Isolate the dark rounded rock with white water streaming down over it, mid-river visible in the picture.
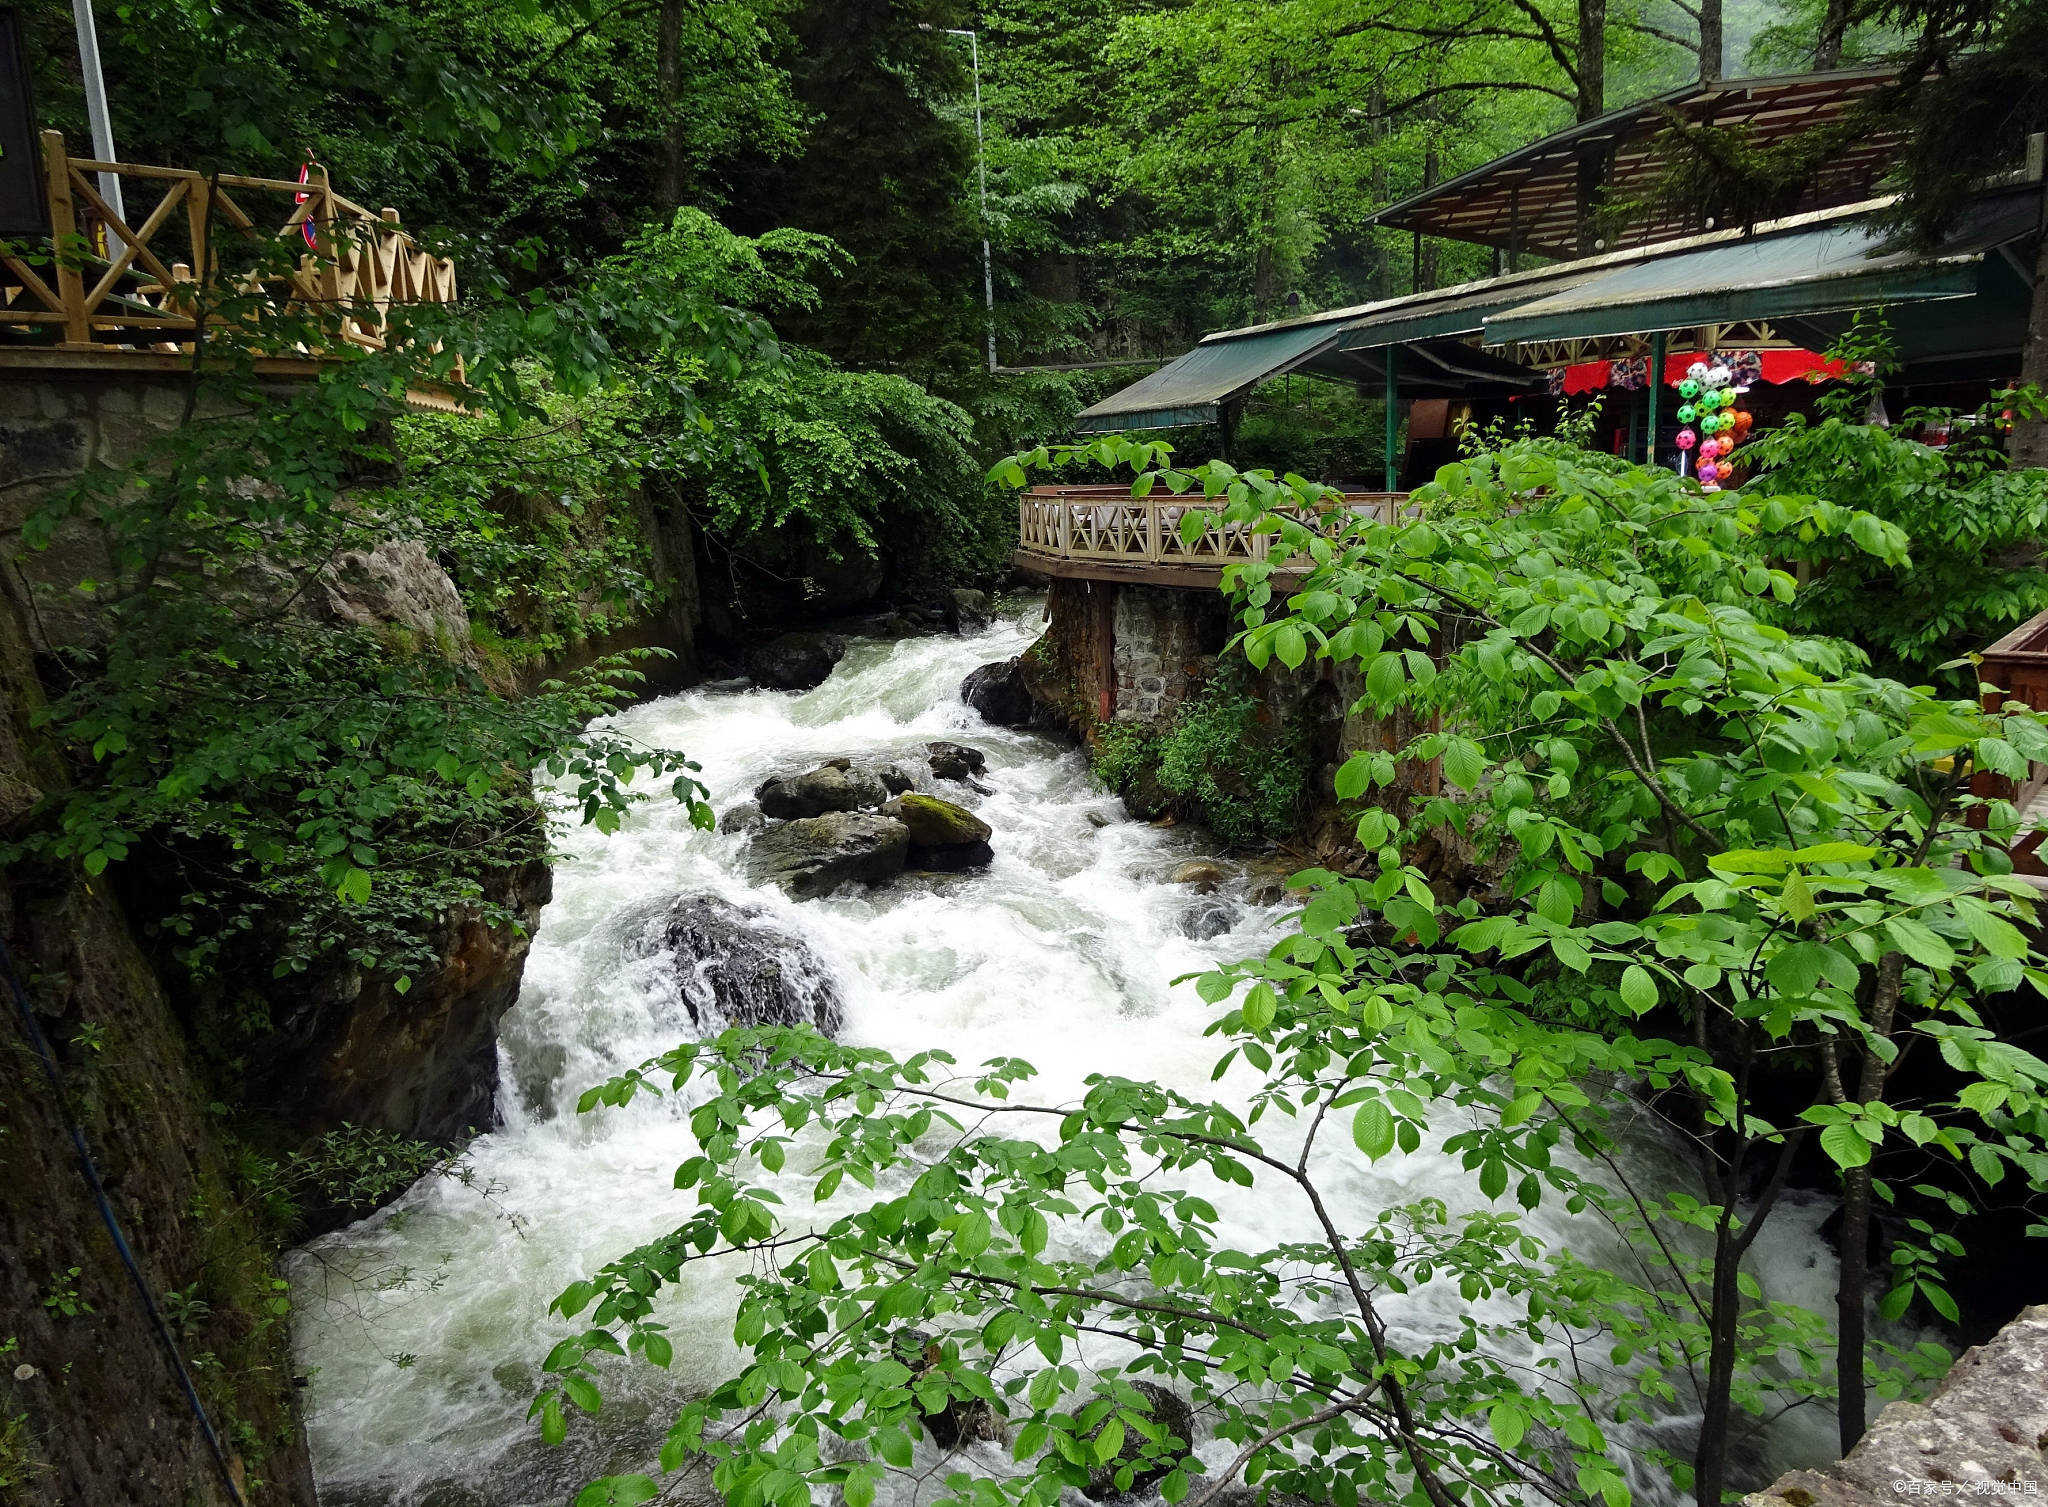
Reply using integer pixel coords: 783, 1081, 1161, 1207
635, 895, 842, 1036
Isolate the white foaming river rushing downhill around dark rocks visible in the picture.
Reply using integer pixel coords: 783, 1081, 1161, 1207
291, 602, 1835, 1507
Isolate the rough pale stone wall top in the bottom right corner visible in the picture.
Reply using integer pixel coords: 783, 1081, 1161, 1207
1743, 1306, 2048, 1507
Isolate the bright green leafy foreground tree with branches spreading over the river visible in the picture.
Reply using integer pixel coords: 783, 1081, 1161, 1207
503, 438, 2048, 1507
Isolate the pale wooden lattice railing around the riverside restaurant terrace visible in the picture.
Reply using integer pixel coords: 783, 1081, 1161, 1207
1018, 487, 1407, 569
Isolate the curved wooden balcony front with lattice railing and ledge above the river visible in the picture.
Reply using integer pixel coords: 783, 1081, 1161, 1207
1012, 485, 1407, 590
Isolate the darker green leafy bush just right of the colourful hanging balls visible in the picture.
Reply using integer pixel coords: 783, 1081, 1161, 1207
1743, 324, 2048, 692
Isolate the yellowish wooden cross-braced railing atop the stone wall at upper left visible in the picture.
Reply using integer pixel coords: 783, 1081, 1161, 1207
0, 131, 455, 356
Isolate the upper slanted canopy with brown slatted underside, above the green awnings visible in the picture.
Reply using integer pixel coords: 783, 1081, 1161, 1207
1372, 70, 1901, 258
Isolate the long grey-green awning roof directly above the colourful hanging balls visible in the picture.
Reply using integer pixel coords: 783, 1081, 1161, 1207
1485, 219, 2007, 346
